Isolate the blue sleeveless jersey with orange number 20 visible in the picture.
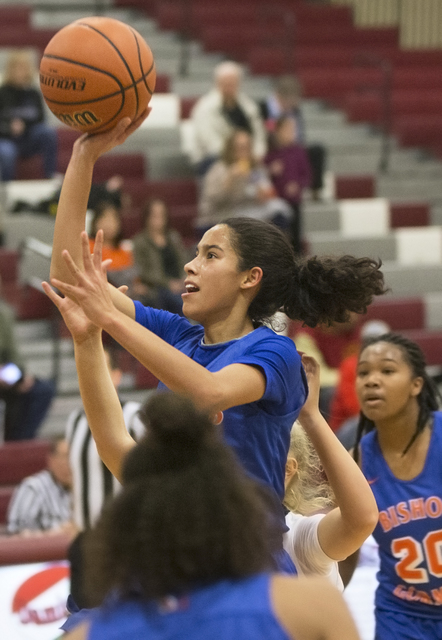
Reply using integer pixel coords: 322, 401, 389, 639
361, 412, 442, 619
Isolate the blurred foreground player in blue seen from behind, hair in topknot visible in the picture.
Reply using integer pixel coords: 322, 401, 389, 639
58, 390, 358, 640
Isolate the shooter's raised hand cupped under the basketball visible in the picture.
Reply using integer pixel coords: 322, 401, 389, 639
74, 107, 152, 162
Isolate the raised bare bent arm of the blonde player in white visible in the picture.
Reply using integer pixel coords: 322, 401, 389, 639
299, 355, 378, 560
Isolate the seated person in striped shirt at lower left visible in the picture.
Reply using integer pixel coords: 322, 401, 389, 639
7, 438, 74, 535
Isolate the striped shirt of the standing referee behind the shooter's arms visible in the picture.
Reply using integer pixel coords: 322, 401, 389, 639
66, 402, 145, 530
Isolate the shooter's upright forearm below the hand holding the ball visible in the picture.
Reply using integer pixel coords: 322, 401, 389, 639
51, 146, 94, 282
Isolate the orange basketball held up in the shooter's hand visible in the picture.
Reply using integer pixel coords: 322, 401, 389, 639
40, 17, 156, 132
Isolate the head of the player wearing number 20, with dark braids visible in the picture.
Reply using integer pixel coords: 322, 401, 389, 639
355, 333, 439, 458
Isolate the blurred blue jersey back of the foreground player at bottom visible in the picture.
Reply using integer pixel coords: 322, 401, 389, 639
88, 574, 289, 640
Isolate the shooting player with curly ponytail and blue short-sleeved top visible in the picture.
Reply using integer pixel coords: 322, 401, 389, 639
44, 111, 384, 560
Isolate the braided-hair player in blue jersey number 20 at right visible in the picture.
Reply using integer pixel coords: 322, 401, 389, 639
354, 333, 442, 640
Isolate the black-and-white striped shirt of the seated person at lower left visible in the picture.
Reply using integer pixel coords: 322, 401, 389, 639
7, 469, 72, 533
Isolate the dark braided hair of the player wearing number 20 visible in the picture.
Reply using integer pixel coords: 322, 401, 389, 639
353, 333, 441, 461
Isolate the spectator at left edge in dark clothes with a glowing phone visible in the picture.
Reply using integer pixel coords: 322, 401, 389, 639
0, 300, 55, 440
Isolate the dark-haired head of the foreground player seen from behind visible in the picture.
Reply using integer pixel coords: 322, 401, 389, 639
86, 393, 273, 602
